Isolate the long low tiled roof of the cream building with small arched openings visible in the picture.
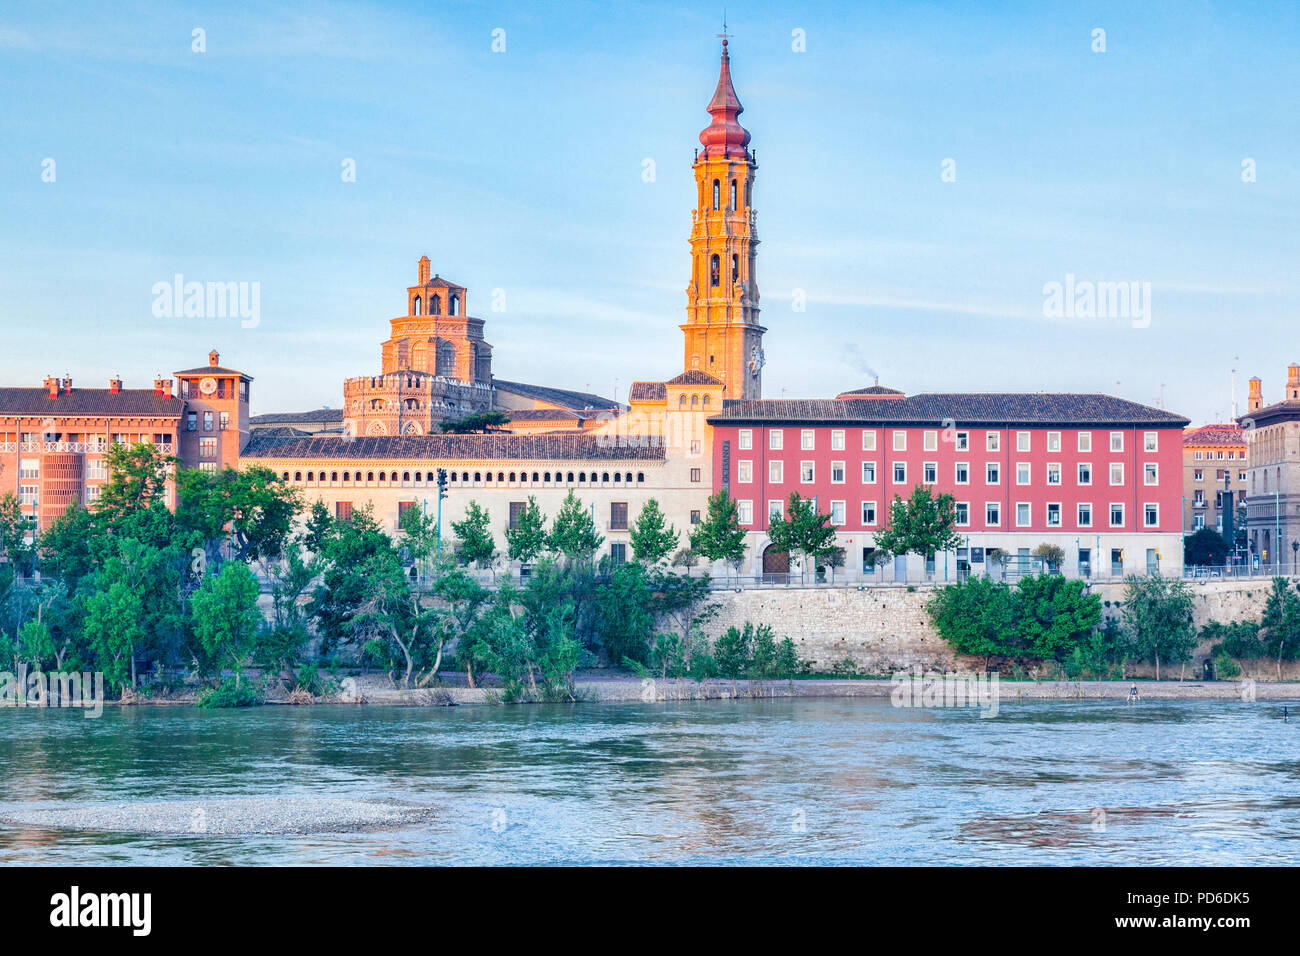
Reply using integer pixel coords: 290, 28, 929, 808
241, 432, 664, 462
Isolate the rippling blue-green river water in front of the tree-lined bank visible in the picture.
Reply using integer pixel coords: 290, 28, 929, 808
0, 698, 1300, 865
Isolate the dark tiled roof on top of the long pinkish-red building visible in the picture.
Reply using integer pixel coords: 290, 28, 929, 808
709, 392, 1188, 427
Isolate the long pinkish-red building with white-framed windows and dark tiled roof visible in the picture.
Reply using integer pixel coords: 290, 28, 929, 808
710, 385, 1187, 580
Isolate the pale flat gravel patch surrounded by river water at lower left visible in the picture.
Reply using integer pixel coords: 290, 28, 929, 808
0, 797, 432, 836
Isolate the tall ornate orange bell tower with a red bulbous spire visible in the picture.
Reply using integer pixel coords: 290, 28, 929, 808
681, 35, 767, 401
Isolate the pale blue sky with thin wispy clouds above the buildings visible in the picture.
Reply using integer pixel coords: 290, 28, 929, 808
0, 0, 1300, 424
